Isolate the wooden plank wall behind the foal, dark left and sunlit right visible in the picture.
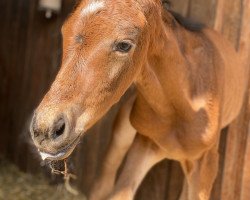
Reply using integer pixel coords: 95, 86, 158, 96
0, 0, 250, 200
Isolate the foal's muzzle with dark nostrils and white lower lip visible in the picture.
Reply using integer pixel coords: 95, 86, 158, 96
30, 113, 75, 159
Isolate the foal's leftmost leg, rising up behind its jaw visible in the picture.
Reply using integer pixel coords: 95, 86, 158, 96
89, 95, 136, 200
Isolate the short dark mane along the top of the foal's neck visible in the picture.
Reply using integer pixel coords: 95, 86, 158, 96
162, 0, 205, 31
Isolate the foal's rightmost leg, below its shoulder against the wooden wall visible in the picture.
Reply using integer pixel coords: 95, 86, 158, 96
180, 145, 219, 200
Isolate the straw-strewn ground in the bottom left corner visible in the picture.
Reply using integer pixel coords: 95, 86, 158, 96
0, 159, 86, 200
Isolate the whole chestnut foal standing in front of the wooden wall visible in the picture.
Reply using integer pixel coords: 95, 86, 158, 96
30, 0, 248, 200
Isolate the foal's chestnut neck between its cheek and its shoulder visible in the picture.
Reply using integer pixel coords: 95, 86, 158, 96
136, 14, 195, 118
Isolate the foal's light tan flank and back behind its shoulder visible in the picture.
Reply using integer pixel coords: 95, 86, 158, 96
204, 29, 248, 127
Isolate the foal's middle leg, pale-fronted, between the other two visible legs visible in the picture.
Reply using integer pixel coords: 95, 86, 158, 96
108, 134, 164, 200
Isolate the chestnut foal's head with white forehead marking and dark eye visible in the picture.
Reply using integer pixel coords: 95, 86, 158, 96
31, 0, 160, 159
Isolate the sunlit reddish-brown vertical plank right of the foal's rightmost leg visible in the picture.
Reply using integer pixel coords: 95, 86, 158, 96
221, 99, 249, 200
